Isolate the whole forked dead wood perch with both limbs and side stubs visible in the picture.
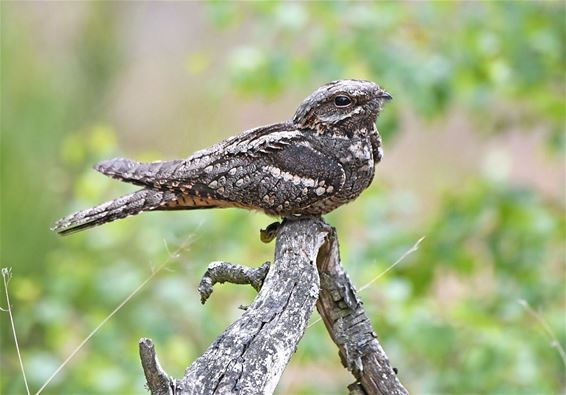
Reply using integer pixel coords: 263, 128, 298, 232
140, 218, 407, 395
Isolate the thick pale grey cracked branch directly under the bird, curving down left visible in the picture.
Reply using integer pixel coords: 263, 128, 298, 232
140, 218, 327, 394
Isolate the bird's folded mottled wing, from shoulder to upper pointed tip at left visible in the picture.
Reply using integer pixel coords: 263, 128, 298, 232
95, 124, 345, 212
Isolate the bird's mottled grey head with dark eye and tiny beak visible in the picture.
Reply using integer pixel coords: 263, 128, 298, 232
293, 80, 392, 132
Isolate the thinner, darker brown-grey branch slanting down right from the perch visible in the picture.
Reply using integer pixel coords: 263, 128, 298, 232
316, 229, 408, 395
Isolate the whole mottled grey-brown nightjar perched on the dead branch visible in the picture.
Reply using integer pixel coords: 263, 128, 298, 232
52, 79, 392, 235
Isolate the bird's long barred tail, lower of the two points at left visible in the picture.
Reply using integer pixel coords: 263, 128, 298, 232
51, 189, 176, 235
